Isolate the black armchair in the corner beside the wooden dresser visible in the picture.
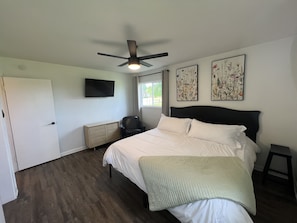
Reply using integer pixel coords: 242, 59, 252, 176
120, 116, 145, 138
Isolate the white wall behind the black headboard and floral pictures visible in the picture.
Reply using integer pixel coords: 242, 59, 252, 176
169, 36, 297, 173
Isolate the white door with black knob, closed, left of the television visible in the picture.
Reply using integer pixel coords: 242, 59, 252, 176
3, 77, 61, 170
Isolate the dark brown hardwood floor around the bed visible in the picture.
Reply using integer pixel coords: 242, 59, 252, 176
3, 148, 297, 223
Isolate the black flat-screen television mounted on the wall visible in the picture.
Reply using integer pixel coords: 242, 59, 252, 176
85, 78, 114, 97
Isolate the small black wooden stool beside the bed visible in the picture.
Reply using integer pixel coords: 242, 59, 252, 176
262, 144, 294, 193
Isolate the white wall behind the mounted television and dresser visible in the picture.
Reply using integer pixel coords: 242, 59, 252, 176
0, 57, 133, 155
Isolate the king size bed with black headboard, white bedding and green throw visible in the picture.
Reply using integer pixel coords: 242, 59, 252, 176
103, 106, 260, 223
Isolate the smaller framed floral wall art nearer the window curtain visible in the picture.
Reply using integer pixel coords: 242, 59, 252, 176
176, 65, 198, 101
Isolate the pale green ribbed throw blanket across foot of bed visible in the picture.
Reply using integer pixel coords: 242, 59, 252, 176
139, 156, 256, 215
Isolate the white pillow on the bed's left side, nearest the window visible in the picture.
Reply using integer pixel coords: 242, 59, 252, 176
157, 114, 191, 134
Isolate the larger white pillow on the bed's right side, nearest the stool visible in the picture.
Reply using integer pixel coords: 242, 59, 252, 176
188, 119, 246, 148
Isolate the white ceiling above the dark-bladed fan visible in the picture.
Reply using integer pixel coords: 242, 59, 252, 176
0, 0, 297, 73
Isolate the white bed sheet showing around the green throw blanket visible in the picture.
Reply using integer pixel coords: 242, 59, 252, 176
103, 129, 257, 223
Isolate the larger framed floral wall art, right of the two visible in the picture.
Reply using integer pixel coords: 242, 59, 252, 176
211, 54, 245, 101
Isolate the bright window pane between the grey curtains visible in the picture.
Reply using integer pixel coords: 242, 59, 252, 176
139, 81, 162, 107
